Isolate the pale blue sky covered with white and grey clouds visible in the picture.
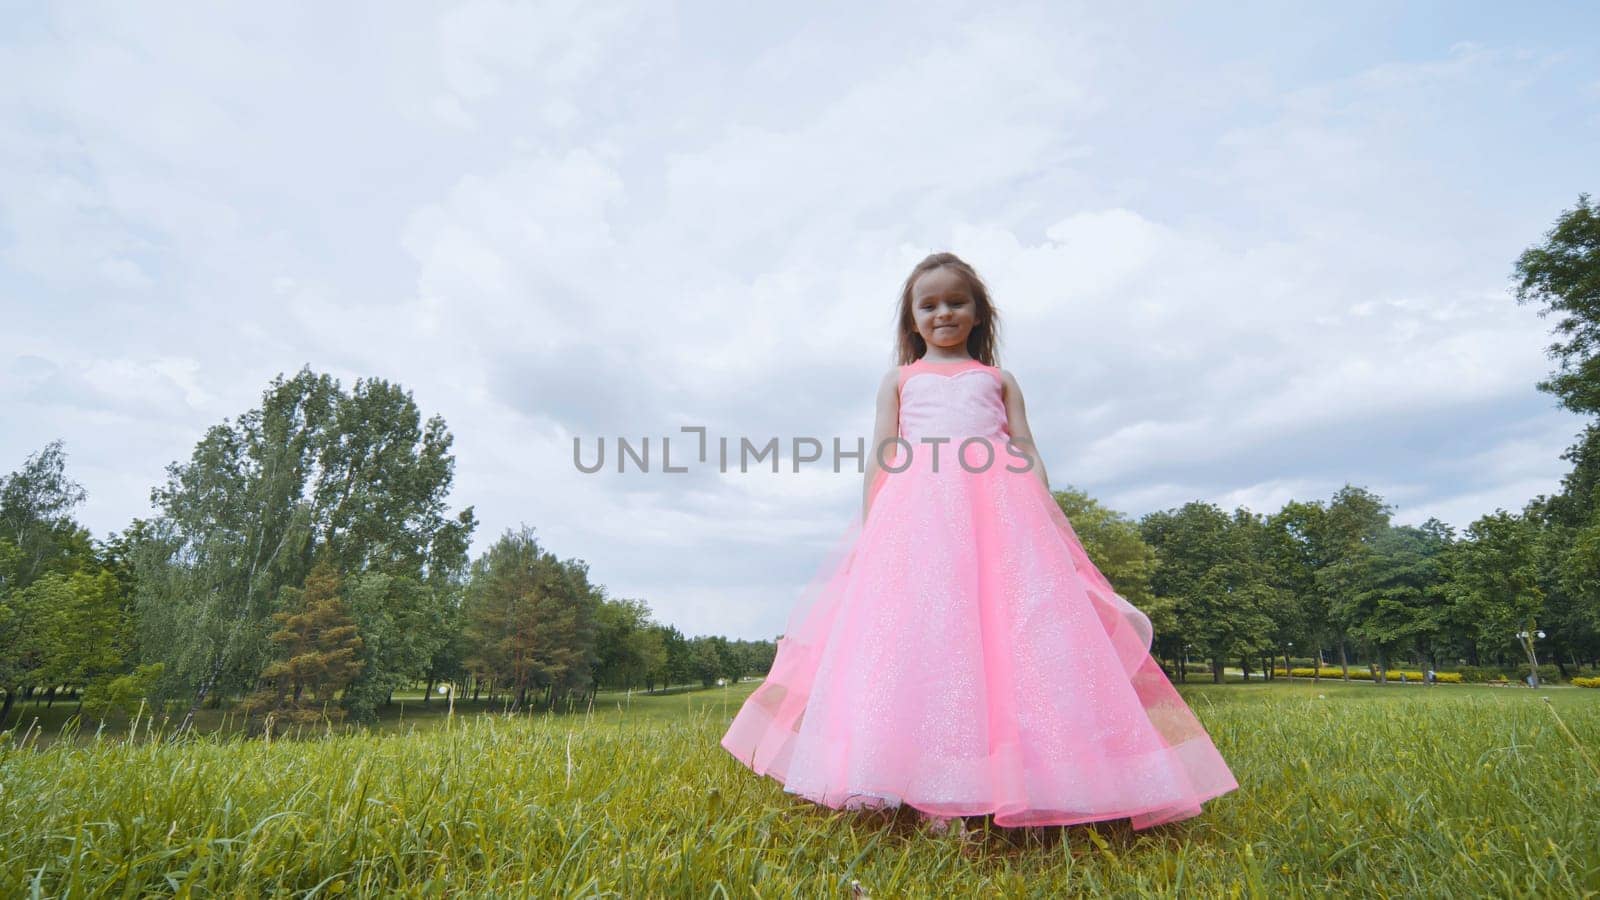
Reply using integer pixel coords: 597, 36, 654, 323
0, 2, 1600, 637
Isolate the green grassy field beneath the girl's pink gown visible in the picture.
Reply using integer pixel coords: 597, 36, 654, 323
0, 681, 1600, 897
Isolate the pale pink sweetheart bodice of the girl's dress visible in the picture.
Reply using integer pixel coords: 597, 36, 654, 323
899, 359, 1010, 444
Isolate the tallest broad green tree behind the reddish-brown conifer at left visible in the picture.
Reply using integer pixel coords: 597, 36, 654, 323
131, 368, 475, 729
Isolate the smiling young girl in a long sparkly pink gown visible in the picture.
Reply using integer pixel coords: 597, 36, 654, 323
722, 253, 1238, 828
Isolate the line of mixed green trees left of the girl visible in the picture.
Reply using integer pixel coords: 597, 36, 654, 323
0, 368, 774, 730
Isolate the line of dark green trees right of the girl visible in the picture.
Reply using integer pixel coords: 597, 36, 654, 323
1056, 194, 1600, 681
